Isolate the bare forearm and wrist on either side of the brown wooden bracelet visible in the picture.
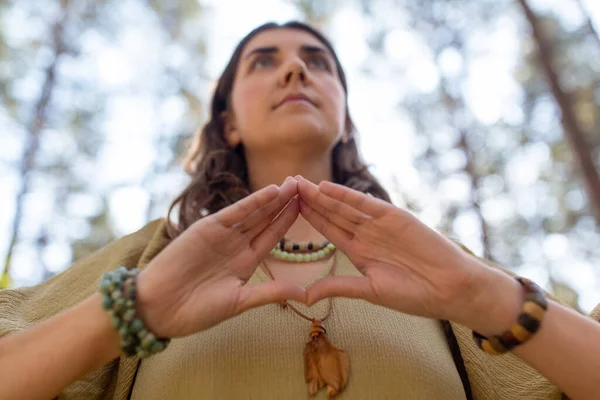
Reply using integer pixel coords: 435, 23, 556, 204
467, 270, 600, 400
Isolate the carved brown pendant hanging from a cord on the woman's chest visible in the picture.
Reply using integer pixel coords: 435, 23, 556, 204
304, 319, 350, 397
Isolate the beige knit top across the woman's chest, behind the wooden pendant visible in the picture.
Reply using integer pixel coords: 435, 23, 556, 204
132, 298, 465, 400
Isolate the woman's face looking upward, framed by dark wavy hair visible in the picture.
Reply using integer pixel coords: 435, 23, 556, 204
226, 29, 346, 153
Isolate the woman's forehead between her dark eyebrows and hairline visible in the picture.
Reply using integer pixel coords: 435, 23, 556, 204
242, 28, 331, 57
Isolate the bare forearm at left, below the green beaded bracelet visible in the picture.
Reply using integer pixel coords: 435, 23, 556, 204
0, 294, 120, 400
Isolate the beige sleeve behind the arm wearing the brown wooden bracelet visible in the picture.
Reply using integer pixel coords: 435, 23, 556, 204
452, 242, 600, 400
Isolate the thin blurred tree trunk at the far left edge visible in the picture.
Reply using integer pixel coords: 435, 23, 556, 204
0, 0, 68, 289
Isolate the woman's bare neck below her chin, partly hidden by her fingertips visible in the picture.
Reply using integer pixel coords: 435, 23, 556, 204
246, 148, 333, 243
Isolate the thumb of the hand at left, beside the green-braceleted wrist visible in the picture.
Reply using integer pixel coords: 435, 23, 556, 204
240, 281, 306, 312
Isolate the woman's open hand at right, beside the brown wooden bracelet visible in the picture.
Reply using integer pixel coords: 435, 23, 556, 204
296, 176, 521, 332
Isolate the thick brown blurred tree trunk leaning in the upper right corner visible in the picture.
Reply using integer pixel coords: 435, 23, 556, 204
518, 0, 600, 225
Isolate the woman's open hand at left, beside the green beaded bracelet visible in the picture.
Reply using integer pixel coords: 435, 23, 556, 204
136, 178, 307, 338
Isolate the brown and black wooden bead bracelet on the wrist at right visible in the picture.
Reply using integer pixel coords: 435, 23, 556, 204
473, 277, 548, 355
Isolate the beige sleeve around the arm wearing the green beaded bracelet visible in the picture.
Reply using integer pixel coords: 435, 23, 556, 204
0, 221, 164, 400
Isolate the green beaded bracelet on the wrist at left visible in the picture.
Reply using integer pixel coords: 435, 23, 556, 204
98, 267, 170, 358
